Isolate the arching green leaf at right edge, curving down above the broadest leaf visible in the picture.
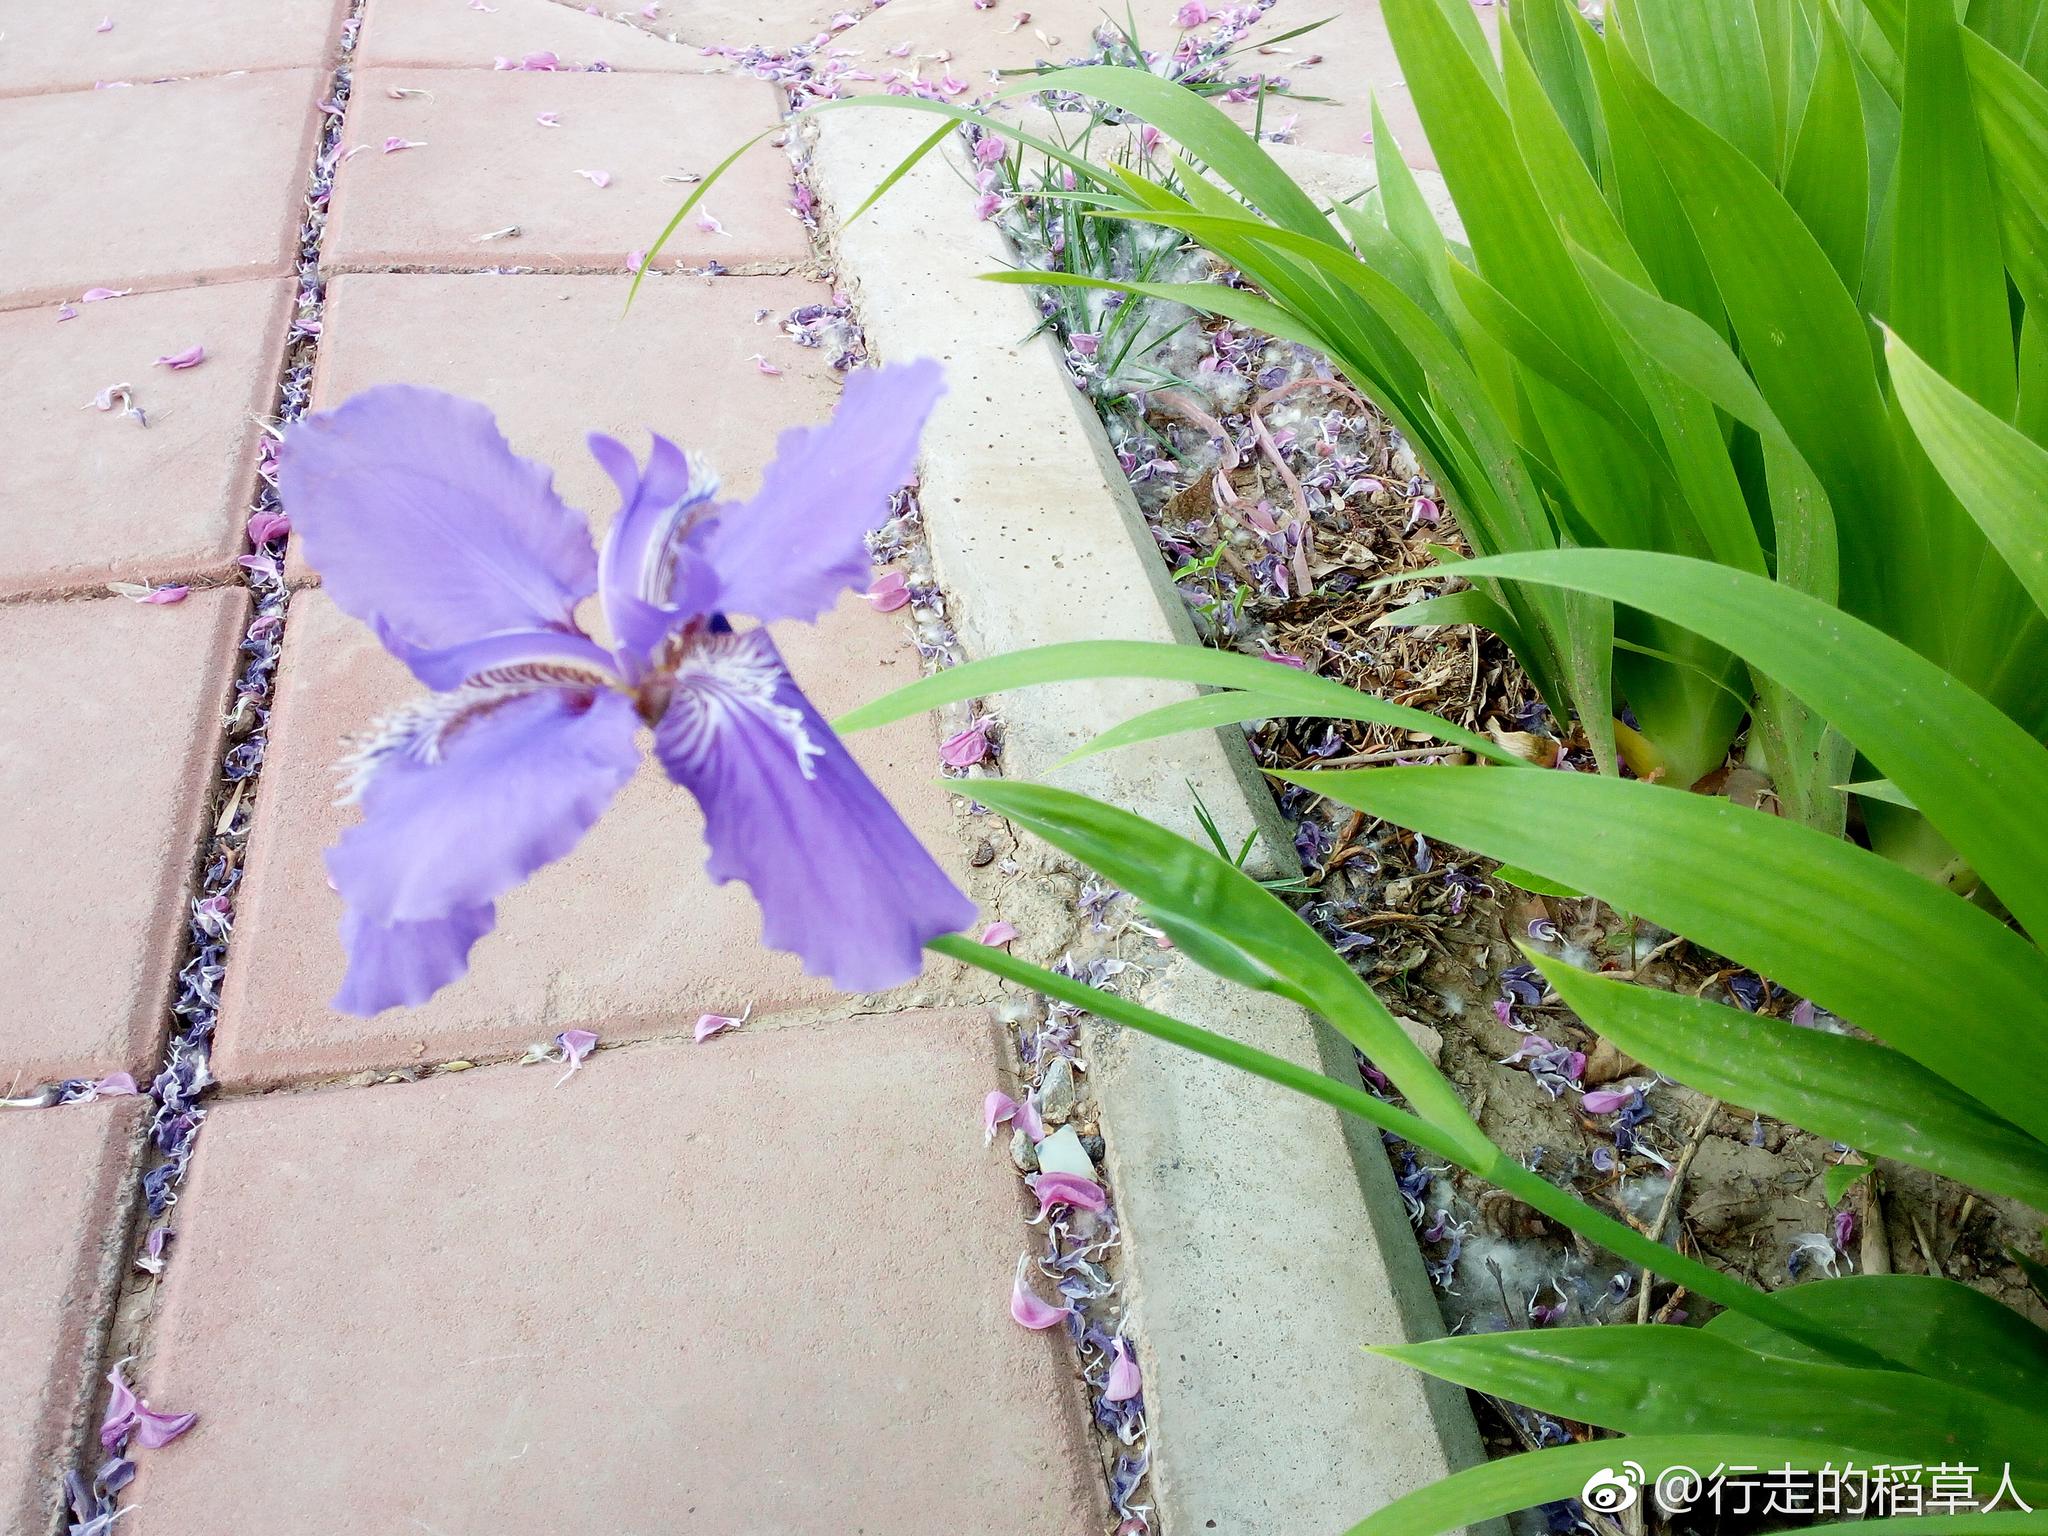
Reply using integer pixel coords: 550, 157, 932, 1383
1458, 549, 2048, 934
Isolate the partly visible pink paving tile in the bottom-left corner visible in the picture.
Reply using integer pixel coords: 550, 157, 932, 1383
0, 1100, 141, 1536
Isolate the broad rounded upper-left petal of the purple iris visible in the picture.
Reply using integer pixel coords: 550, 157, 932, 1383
279, 385, 598, 649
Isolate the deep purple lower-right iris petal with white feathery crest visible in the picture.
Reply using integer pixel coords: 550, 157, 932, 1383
655, 629, 975, 991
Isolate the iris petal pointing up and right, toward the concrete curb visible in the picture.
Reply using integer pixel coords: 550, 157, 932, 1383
705, 358, 946, 625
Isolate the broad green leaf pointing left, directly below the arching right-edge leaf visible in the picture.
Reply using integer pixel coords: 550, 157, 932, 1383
1276, 768, 2048, 1139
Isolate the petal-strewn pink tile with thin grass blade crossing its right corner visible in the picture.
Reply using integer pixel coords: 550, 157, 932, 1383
322, 70, 811, 272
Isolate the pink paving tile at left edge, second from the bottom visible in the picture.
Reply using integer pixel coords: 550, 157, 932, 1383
0, 588, 246, 1083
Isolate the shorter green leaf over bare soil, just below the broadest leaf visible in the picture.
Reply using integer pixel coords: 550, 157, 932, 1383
1534, 956, 2048, 1210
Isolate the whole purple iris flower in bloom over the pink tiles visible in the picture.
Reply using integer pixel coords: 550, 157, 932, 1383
279, 362, 975, 1014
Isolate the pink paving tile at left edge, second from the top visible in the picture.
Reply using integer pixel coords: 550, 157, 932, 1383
0, 70, 326, 309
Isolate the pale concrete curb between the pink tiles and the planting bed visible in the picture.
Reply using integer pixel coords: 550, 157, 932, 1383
811, 111, 1481, 1536
